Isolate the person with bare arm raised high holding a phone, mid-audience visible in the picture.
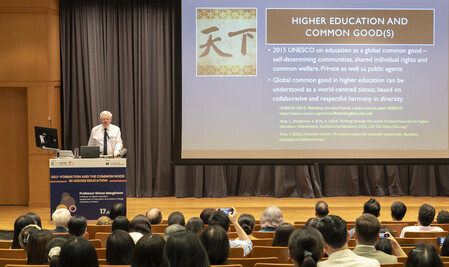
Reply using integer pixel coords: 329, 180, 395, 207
209, 207, 253, 256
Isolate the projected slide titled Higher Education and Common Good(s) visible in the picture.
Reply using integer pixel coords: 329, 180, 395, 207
179, 0, 449, 160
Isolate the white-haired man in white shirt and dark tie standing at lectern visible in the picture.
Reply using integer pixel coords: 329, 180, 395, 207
88, 110, 123, 157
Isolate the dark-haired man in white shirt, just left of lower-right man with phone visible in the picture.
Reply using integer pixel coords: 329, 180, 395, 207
317, 215, 380, 267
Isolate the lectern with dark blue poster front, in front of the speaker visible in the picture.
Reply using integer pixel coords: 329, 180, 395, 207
50, 158, 126, 220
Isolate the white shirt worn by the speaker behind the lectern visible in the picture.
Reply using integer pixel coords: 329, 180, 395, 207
88, 124, 123, 155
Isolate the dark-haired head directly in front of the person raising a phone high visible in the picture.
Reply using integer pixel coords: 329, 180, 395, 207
200, 225, 230, 265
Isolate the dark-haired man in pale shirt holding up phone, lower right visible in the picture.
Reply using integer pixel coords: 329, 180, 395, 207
353, 213, 407, 263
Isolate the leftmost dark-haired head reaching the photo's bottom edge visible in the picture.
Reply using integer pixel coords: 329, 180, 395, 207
26, 230, 52, 265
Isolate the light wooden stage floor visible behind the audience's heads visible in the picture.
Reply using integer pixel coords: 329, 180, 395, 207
0, 196, 449, 230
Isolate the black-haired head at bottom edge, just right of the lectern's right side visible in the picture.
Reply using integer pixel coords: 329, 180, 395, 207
132, 234, 165, 267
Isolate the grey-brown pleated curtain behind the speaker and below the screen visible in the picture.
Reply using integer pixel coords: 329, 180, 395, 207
60, 0, 449, 198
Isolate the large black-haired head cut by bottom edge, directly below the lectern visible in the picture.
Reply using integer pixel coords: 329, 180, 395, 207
58, 237, 98, 267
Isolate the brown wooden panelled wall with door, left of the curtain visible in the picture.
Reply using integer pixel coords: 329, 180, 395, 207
0, 0, 61, 206
